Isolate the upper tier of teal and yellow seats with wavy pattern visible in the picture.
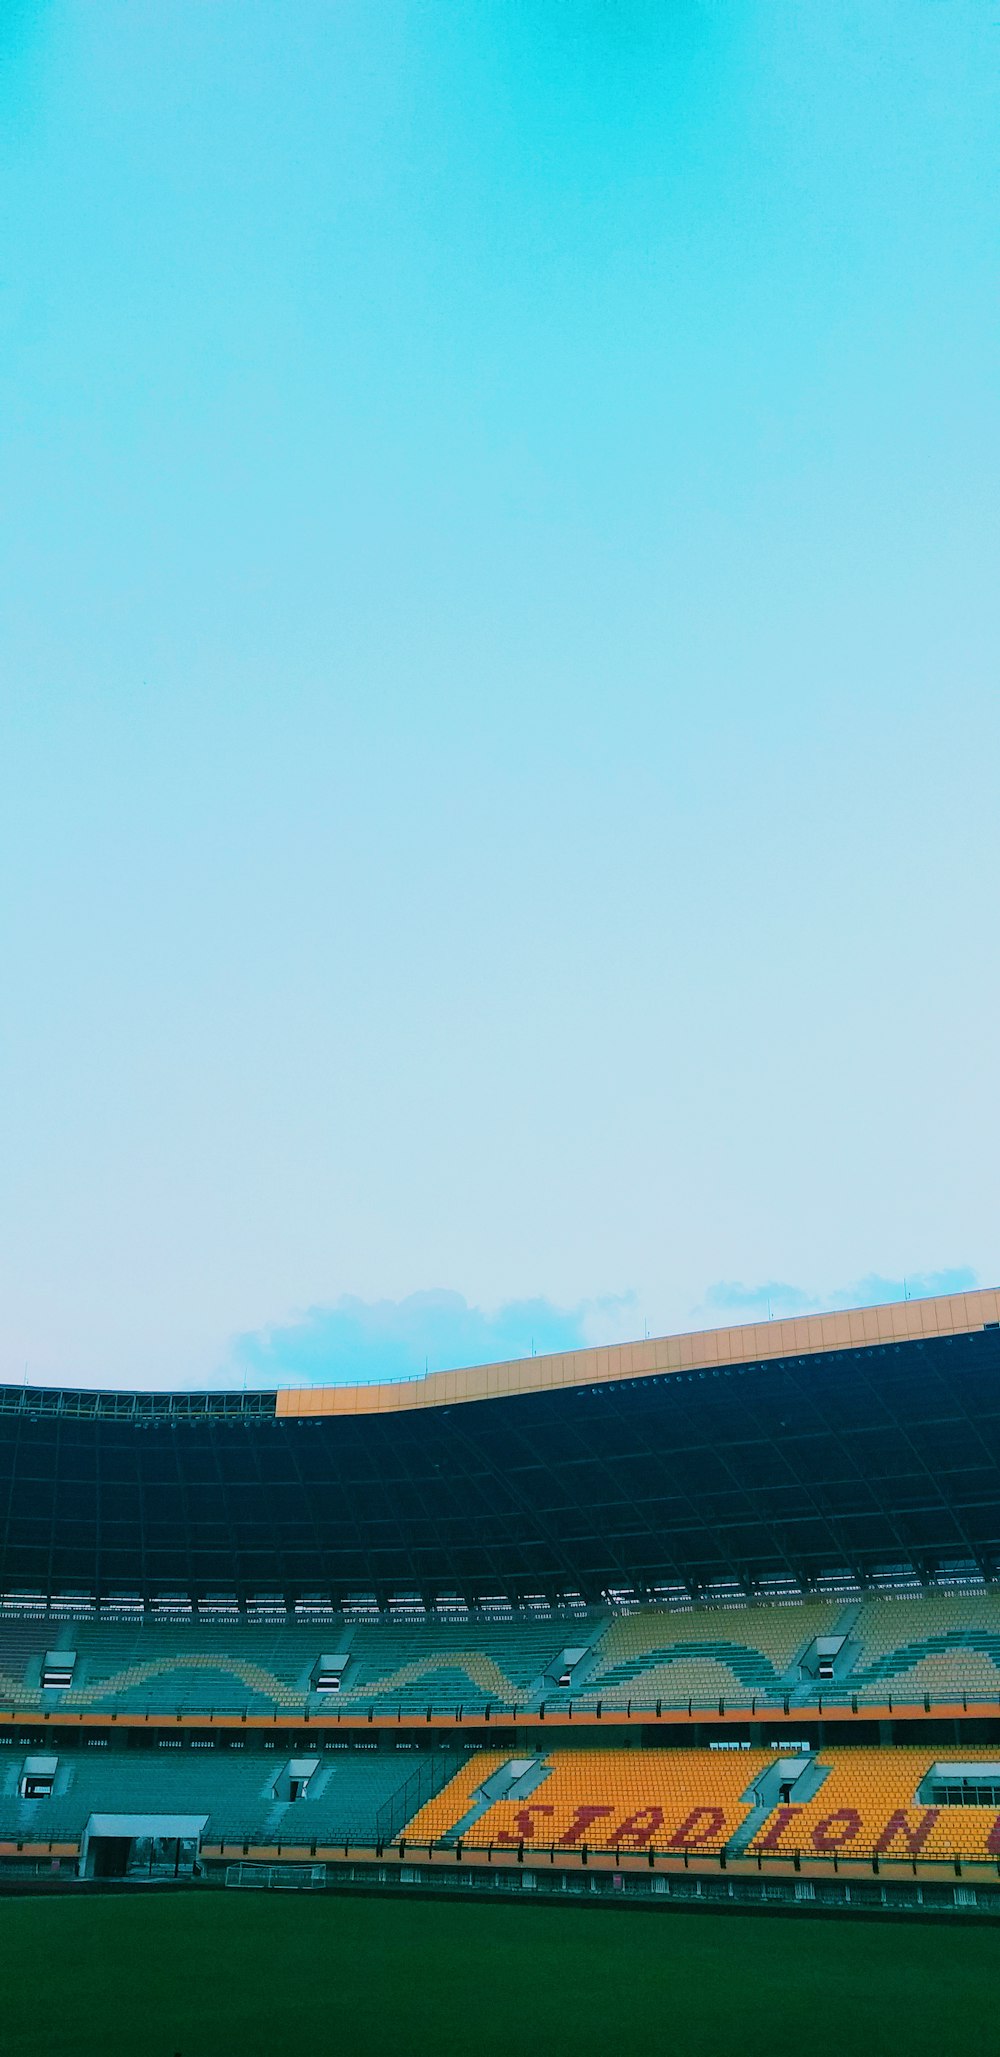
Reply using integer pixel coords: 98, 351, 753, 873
0, 1586, 1000, 1722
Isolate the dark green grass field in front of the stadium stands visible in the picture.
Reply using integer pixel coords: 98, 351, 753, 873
0, 1892, 1000, 2057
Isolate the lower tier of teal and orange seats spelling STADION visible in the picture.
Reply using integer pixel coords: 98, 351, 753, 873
0, 1738, 1000, 1864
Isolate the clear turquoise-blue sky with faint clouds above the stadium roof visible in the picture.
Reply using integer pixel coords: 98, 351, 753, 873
0, 0, 1000, 1384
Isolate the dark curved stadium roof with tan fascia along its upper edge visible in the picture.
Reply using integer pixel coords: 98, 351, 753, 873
0, 1292, 1000, 1604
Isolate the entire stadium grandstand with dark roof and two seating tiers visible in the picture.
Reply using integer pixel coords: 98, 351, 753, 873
0, 1292, 1000, 1913
